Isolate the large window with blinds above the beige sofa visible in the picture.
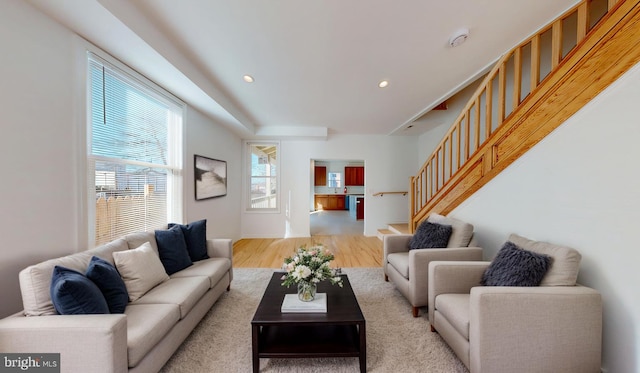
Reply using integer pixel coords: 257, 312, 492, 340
87, 53, 184, 245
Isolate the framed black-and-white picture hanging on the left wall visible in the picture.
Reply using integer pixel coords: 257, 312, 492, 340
193, 154, 227, 201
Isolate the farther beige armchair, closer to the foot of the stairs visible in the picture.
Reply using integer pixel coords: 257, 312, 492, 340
382, 214, 482, 317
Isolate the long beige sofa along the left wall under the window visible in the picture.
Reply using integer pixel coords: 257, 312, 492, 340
0, 232, 233, 372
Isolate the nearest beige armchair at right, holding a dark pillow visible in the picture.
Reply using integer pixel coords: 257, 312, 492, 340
428, 235, 602, 373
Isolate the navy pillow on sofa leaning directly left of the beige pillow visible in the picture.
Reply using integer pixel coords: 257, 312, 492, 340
86, 256, 129, 313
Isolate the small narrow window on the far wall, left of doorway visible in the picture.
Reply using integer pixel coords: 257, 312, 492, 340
247, 143, 278, 211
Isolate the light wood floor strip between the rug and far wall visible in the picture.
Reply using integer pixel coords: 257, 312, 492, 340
233, 235, 382, 268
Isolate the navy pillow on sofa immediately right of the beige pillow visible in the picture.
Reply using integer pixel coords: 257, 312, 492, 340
155, 222, 193, 275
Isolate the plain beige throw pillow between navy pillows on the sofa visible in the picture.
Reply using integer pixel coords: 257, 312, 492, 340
113, 242, 169, 302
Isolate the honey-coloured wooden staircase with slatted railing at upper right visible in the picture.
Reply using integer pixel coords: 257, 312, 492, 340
408, 0, 640, 234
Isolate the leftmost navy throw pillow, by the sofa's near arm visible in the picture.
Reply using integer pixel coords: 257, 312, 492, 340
50, 266, 109, 315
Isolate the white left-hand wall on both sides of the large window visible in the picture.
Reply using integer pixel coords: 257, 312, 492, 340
0, 1, 241, 317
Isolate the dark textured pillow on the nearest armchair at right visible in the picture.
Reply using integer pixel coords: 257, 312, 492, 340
480, 241, 551, 286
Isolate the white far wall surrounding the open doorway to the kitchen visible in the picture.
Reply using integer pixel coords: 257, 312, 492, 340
242, 135, 419, 238
